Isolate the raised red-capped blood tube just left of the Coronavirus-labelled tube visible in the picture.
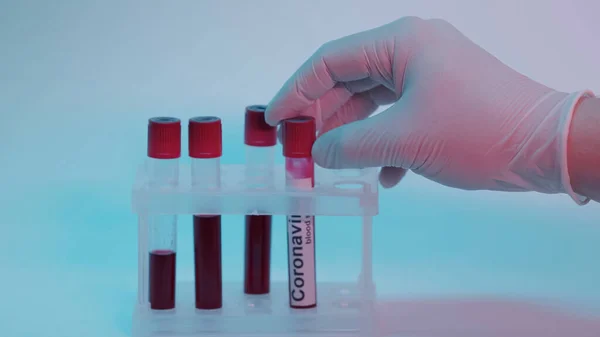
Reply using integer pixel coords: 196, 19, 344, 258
244, 105, 277, 295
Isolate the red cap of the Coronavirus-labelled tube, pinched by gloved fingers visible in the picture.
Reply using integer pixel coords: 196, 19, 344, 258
281, 116, 317, 158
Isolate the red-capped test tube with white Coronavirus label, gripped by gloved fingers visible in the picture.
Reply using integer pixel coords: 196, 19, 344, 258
282, 117, 317, 309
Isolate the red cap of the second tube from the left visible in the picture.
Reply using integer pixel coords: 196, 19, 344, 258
188, 116, 223, 159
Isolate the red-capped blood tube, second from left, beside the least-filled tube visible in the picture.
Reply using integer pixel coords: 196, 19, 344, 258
188, 116, 223, 310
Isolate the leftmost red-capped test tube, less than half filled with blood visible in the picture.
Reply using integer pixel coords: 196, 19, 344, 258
148, 117, 181, 310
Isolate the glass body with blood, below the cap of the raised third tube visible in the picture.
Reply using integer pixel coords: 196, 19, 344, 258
244, 145, 275, 295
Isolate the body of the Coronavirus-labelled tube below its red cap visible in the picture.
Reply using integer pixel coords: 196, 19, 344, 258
286, 158, 317, 308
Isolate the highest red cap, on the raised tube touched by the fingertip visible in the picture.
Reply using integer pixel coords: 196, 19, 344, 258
244, 105, 277, 146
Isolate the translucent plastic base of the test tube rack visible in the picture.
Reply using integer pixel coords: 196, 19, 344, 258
133, 281, 374, 337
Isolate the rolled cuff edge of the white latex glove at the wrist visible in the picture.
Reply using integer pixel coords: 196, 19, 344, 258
558, 90, 594, 205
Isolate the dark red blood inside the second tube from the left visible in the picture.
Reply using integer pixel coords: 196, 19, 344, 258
194, 215, 223, 309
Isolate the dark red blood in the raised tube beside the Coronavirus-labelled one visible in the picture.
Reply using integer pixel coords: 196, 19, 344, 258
244, 215, 272, 294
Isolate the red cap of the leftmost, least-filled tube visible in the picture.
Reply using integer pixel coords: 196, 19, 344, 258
148, 117, 181, 159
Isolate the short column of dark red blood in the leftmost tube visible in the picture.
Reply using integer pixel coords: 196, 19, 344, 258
149, 250, 176, 310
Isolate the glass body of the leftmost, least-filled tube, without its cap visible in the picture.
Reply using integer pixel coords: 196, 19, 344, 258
147, 158, 179, 310
